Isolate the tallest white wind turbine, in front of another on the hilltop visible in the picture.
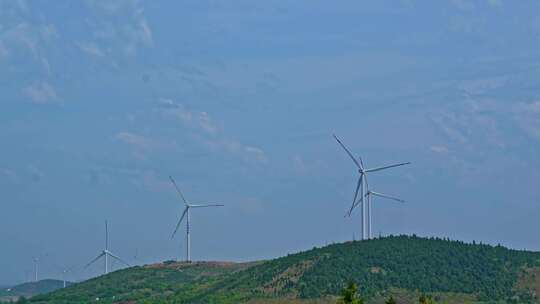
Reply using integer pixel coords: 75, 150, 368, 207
334, 134, 410, 240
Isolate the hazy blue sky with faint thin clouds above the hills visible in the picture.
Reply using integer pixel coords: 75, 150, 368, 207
0, 0, 540, 284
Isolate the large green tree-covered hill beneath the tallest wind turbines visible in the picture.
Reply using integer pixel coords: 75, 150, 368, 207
27, 236, 540, 303
